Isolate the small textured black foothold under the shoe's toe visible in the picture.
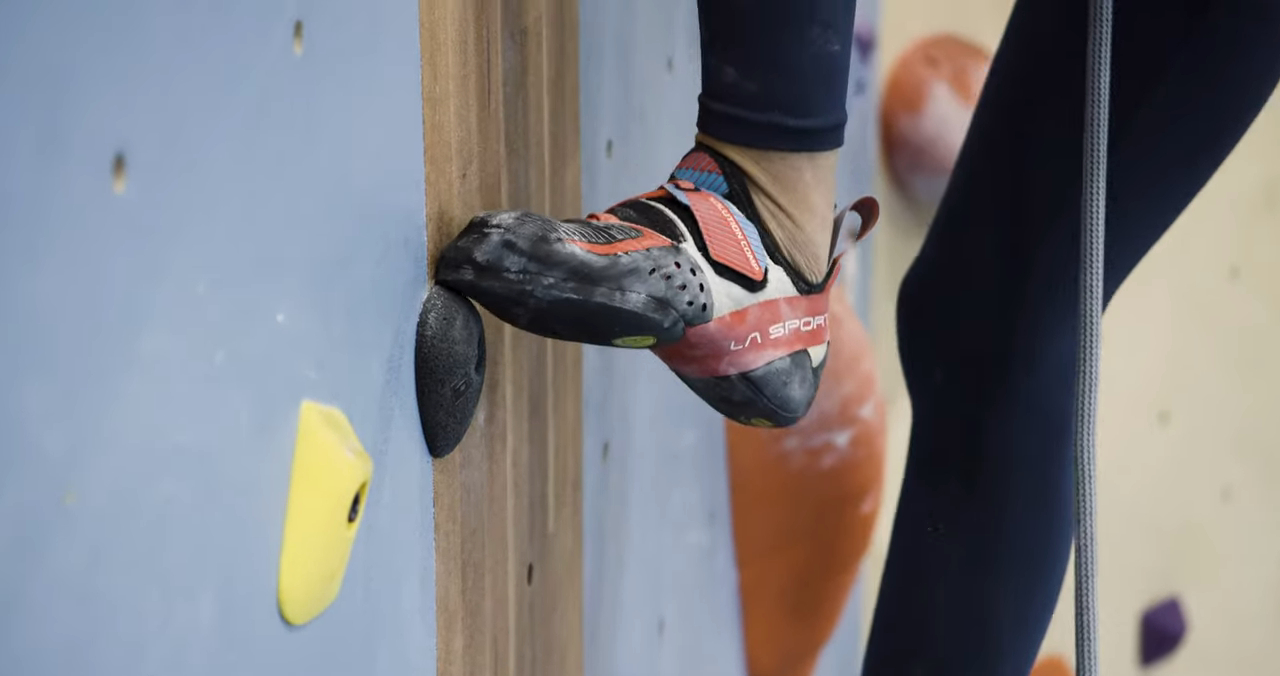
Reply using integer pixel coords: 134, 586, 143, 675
413, 286, 485, 458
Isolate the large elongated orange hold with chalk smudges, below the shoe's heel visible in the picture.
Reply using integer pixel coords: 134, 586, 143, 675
727, 280, 884, 676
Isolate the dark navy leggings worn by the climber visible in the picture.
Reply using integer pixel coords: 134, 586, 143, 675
699, 0, 1280, 676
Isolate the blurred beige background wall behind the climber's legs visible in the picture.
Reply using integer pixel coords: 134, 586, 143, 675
864, 0, 1280, 676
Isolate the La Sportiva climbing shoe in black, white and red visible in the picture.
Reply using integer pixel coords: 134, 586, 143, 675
435, 145, 877, 426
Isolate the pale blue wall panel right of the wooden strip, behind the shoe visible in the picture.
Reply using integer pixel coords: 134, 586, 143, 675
580, 0, 877, 676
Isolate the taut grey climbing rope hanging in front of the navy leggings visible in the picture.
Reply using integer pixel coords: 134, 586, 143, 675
1075, 0, 1112, 676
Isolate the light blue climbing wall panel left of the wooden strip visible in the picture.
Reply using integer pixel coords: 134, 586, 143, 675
0, 0, 435, 676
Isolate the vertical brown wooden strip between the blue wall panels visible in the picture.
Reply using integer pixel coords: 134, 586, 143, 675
419, 0, 582, 676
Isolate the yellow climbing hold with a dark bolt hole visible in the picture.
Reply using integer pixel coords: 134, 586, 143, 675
276, 401, 374, 625
